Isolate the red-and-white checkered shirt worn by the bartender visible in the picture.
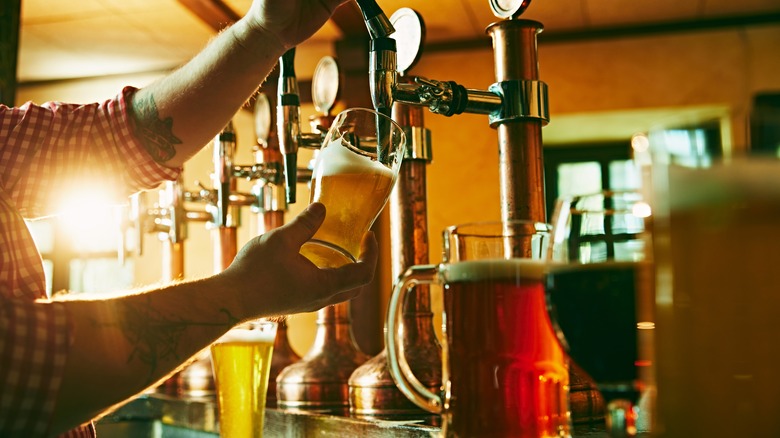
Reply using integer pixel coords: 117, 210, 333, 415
0, 87, 179, 438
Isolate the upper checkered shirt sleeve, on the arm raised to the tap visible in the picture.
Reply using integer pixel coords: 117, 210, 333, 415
0, 87, 179, 217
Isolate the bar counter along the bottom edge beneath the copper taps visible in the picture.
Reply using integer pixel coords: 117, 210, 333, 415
97, 393, 624, 438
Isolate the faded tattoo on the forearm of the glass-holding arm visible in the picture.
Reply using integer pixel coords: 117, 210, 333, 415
99, 297, 239, 384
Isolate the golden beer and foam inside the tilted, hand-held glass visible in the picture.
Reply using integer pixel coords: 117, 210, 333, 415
301, 138, 395, 267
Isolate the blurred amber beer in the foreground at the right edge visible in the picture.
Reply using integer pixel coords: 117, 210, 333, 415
654, 159, 780, 438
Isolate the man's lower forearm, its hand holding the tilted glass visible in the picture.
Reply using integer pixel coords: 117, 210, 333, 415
49, 279, 243, 431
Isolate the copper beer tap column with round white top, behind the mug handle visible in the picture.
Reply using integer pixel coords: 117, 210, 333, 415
349, 8, 441, 425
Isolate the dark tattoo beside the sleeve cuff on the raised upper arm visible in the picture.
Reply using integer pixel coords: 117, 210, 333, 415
131, 95, 182, 164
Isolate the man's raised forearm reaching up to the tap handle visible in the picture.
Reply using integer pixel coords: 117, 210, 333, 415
130, 19, 284, 167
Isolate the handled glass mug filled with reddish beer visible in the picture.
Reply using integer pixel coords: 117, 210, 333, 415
386, 221, 570, 438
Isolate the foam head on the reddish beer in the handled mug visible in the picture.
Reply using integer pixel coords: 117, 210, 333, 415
445, 259, 547, 282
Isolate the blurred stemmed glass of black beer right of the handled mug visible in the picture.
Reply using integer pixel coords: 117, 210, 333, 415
547, 190, 654, 438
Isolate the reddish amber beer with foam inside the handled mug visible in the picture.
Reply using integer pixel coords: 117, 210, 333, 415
443, 259, 569, 438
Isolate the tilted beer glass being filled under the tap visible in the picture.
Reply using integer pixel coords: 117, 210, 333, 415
301, 108, 406, 267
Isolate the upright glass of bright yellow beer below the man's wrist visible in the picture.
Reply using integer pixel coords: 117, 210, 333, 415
211, 320, 277, 438
